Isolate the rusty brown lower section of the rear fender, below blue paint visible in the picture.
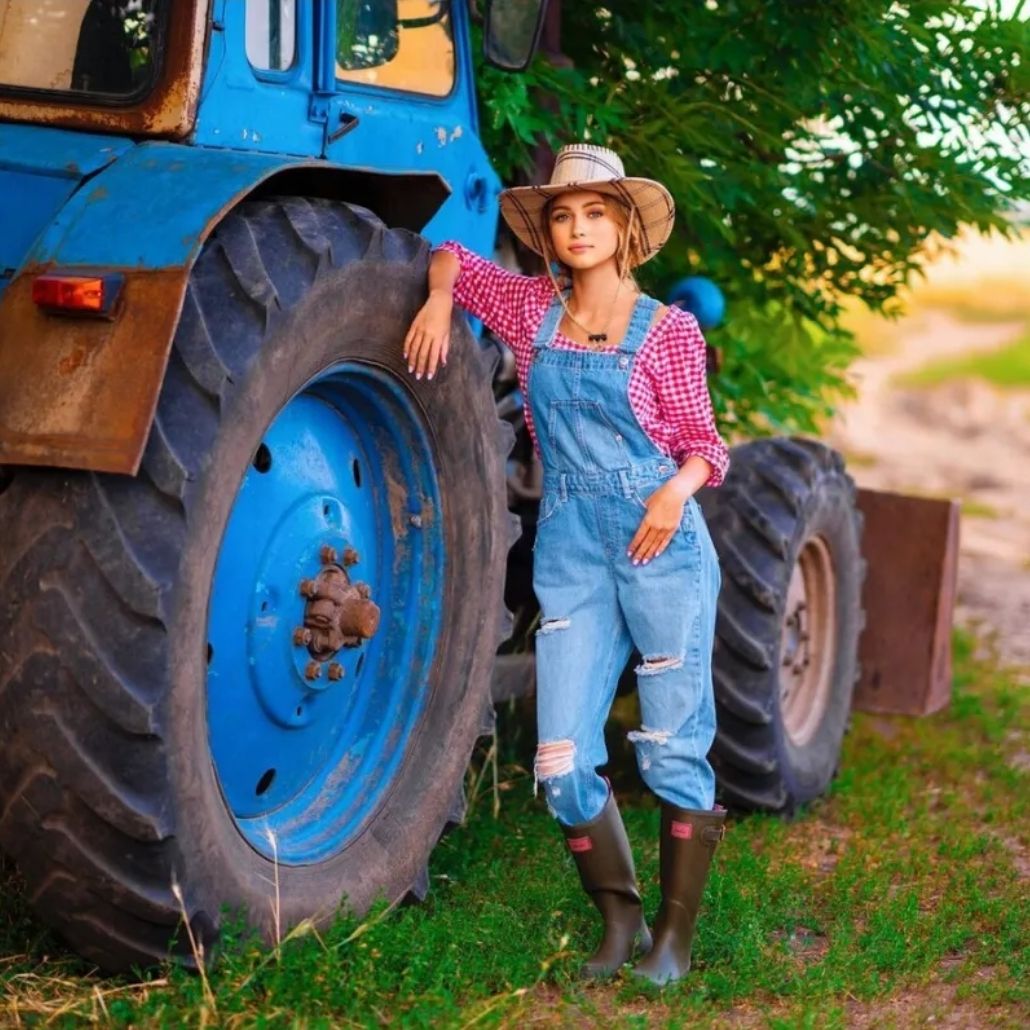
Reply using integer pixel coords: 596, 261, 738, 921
0, 266, 190, 474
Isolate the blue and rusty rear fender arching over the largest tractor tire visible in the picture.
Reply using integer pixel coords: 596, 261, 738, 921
0, 142, 450, 475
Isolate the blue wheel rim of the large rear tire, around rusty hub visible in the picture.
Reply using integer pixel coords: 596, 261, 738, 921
207, 362, 444, 864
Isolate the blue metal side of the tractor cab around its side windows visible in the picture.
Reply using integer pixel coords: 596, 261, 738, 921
194, 0, 501, 253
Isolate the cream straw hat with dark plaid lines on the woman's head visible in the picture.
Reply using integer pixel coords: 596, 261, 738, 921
501, 143, 676, 264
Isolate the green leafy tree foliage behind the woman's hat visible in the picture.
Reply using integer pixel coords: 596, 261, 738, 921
479, 0, 1030, 434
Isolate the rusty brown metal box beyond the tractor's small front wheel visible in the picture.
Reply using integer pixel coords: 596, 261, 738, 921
854, 489, 959, 715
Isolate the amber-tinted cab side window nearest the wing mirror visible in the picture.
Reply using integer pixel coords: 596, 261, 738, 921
336, 0, 454, 97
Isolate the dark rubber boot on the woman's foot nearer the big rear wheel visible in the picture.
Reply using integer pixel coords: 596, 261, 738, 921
561, 793, 651, 979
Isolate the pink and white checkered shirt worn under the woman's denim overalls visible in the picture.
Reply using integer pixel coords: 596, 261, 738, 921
439, 241, 729, 486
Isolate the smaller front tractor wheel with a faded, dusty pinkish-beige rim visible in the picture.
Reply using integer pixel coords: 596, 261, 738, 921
698, 438, 865, 814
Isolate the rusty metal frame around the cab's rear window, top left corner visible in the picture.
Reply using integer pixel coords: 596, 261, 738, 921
0, 0, 210, 139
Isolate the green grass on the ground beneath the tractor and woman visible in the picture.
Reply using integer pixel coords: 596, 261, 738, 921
0, 633, 1030, 1028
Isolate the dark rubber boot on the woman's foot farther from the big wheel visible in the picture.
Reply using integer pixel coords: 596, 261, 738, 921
632, 802, 726, 985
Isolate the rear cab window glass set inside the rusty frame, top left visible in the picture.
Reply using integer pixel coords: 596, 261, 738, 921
0, 0, 171, 102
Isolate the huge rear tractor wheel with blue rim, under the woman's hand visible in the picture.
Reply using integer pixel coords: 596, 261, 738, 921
0, 199, 512, 970
